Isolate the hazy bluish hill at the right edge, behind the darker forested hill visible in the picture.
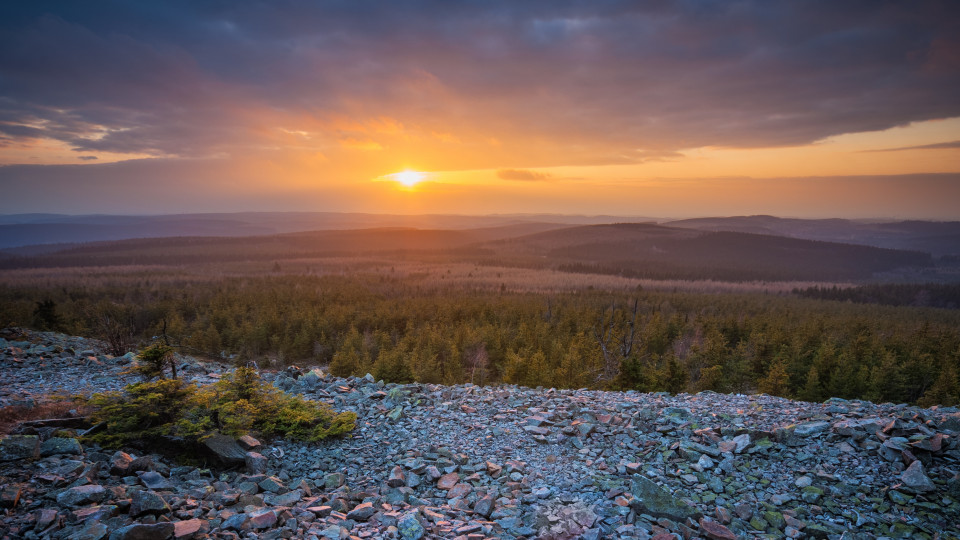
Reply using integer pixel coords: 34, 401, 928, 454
664, 216, 960, 257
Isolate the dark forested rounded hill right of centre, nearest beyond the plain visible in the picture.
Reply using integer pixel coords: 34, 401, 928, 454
483, 224, 933, 281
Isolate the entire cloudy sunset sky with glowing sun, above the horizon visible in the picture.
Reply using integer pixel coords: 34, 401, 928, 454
0, 0, 960, 220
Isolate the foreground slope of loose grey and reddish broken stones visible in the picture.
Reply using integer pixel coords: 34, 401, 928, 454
0, 326, 960, 540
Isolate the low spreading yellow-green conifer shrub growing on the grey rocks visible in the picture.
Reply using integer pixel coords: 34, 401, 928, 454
88, 368, 356, 448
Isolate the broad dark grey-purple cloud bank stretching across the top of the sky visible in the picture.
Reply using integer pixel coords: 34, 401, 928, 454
0, 0, 960, 166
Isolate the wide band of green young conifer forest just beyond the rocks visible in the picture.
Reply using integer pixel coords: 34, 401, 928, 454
0, 274, 960, 405
